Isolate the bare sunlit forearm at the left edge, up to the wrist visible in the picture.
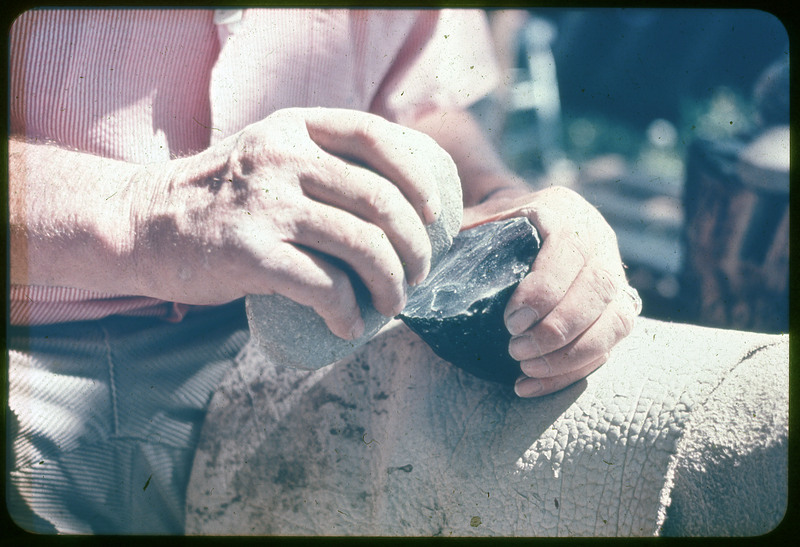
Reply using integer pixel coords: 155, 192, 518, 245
9, 139, 169, 294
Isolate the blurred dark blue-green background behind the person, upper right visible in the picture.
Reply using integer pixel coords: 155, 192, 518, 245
475, 8, 790, 332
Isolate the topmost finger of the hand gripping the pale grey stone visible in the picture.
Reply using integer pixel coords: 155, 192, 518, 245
306, 109, 452, 224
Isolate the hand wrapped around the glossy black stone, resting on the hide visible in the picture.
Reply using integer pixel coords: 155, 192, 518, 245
462, 187, 641, 397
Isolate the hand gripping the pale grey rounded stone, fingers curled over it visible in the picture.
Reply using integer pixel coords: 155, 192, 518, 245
132, 108, 446, 338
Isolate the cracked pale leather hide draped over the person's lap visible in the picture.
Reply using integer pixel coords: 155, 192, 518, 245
187, 319, 788, 536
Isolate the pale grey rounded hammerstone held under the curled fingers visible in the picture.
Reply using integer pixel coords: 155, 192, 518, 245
246, 147, 463, 369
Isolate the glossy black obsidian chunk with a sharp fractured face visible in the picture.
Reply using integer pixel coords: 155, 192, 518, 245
399, 218, 541, 384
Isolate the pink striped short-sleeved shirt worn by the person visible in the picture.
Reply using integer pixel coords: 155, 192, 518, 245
10, 9, 498, 324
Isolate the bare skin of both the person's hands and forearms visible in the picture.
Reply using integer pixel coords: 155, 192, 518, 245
9, 108, 636, 396
